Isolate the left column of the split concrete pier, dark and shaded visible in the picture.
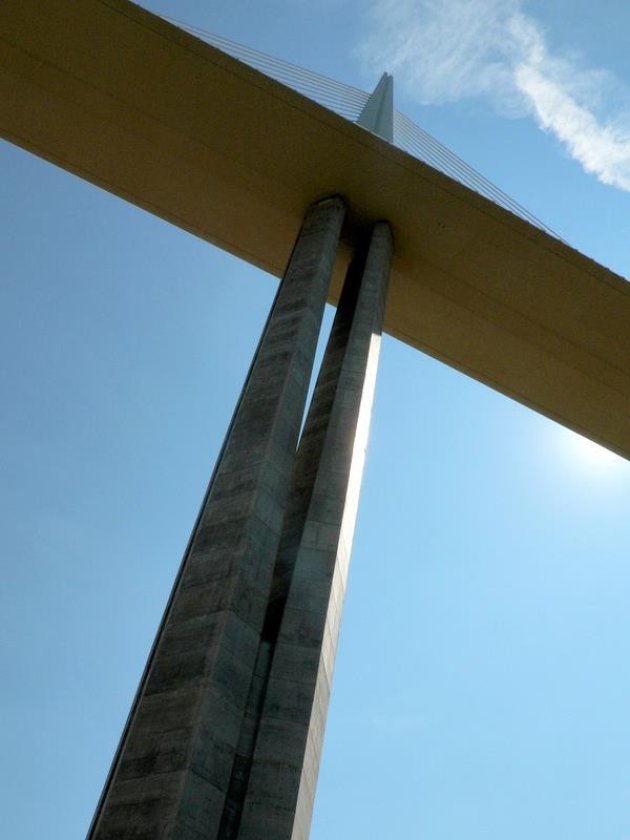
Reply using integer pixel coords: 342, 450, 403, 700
89, 198, 344, 840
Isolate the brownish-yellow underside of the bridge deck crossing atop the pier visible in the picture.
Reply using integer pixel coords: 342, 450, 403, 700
0, 0, 630, 457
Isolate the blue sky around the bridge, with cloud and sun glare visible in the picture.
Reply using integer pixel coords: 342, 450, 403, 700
0, 0, 630, 840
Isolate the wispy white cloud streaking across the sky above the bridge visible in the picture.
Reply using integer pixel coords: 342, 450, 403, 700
361, 0, 630, 190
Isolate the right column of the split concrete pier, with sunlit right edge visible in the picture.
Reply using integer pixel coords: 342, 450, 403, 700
237, 223, 392, 840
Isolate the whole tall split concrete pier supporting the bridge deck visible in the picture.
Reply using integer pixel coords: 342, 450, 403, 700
89, 198, 391, 840
